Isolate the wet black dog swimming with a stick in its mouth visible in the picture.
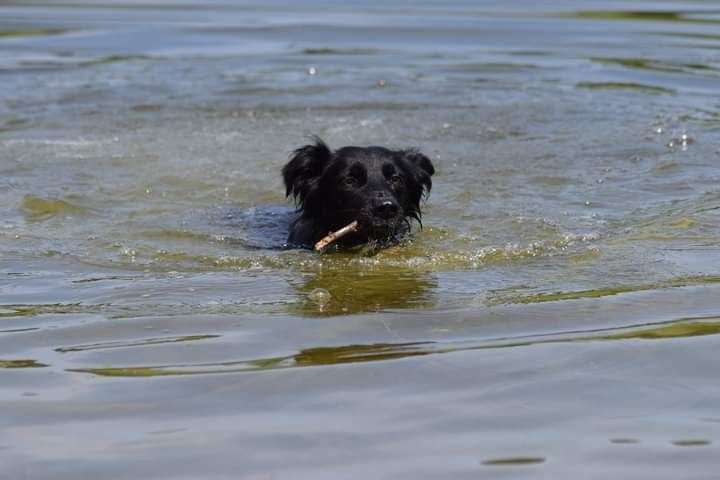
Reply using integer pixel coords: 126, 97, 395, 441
282, 138, 435, 248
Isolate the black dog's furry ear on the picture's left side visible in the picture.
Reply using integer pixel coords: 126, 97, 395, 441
282, 137, 332, 206
